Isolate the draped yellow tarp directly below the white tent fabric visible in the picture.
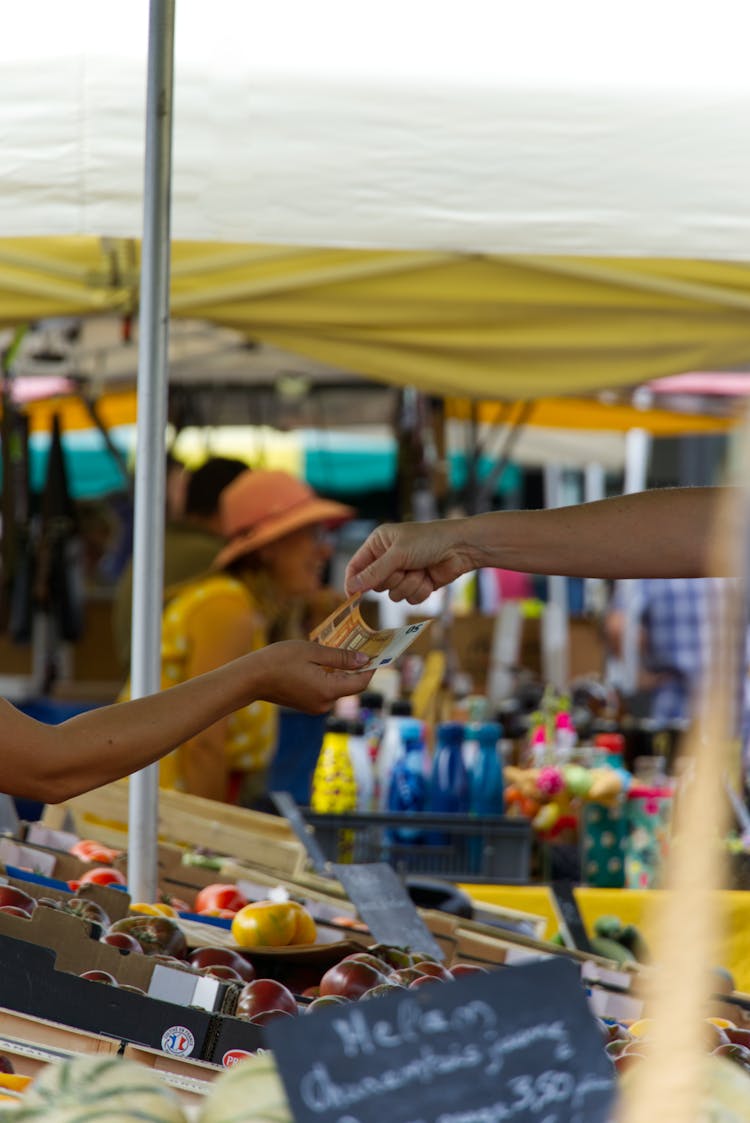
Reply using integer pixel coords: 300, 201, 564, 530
0, 238, 750, 399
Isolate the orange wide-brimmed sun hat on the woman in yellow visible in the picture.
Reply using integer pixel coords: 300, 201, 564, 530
213, 471, 356, 569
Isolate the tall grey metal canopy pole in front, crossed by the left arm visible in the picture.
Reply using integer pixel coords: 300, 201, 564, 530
128, 0, 175, 901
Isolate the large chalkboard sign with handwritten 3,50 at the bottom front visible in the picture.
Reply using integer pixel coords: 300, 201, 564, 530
265, 959, 614, 1123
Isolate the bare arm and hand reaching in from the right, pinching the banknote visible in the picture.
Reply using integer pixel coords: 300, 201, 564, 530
346, 487, 722, 604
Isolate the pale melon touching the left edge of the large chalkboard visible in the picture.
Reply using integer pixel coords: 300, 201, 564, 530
199, 1052, 293, 1123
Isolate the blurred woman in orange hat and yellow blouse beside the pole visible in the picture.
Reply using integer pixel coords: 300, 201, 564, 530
139, 471, 355, 805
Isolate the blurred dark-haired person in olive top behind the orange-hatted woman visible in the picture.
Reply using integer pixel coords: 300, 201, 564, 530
112, 456, 248, 675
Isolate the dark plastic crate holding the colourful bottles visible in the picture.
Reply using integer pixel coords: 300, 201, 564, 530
301, 807, 531, 885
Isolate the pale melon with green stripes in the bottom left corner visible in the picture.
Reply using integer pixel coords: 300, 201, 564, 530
12, 1056, 186, 1123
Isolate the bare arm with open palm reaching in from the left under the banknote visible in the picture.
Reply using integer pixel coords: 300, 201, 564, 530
0, 640, 372, 803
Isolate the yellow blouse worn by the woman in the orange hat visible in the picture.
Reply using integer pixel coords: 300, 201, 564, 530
121, 573, 277, 791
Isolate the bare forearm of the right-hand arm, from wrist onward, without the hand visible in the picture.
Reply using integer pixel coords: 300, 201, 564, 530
464, 487, 721, 578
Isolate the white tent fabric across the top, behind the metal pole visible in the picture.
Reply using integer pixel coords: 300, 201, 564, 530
5, 0, 750, 259
